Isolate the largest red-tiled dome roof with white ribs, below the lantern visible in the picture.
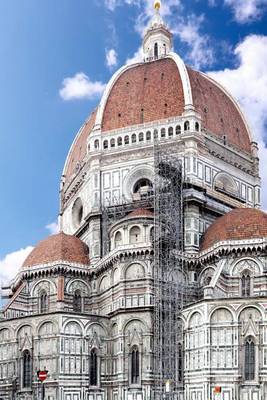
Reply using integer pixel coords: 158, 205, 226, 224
64, 56, 252, 184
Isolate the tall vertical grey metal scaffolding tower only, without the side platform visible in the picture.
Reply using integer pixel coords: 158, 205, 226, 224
154, 144, 185, 399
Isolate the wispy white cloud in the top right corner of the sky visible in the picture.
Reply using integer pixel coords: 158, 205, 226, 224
224, 0, 267, 23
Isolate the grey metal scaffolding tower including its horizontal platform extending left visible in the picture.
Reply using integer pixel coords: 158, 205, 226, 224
101, 142, 192, 400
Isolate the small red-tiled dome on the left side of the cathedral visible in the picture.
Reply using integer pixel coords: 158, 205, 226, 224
22, 232, 90, 268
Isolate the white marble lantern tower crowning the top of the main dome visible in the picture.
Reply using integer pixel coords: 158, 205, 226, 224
143, 0, 172, 61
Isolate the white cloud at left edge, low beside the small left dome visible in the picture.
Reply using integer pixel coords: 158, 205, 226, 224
0, 246, 33, 283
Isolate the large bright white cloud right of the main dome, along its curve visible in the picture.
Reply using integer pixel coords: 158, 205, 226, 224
209, 35, 267, 209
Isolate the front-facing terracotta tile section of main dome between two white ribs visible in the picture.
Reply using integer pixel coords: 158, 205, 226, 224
102, 58, 184, 131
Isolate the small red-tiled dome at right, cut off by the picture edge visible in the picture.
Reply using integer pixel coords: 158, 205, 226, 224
200, 208, 267, 250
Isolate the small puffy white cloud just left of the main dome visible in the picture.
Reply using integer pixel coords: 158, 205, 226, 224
59, 72, 106, 100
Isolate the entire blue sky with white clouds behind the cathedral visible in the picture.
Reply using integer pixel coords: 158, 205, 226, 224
0, 0, 267, 282
